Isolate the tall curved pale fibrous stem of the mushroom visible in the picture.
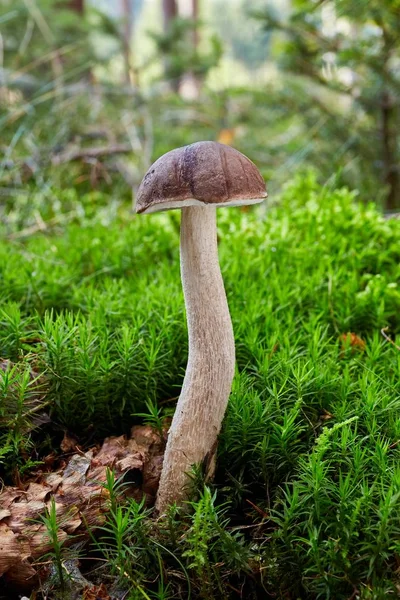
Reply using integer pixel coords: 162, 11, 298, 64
156, 206, 235, 513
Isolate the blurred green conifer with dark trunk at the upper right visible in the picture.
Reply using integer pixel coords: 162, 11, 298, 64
255, 0, 400, 210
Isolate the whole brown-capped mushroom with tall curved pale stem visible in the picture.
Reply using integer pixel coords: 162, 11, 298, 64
136, 142, 267, 513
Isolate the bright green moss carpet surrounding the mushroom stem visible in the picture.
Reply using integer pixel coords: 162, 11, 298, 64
0, 173, 400, 598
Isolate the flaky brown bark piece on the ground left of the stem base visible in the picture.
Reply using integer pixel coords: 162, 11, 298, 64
0, 426, 164, 589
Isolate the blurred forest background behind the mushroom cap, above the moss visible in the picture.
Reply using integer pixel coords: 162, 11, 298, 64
0, 0, 400, 213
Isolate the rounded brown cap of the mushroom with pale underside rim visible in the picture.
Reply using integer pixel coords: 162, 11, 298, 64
136, 142, 267, 213
